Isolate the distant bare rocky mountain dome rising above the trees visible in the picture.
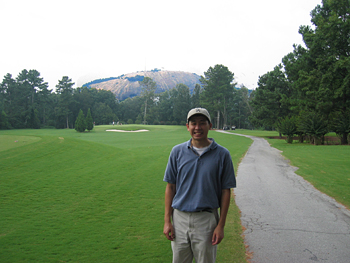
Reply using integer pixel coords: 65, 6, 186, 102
83, 69, 200, 101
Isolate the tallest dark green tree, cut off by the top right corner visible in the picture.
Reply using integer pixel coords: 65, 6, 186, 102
297, 0, 350, 142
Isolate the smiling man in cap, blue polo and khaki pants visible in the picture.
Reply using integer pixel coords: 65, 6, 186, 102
163, 108, 236, 263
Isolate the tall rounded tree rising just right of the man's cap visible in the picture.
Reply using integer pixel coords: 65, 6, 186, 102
200, 65, 235, 128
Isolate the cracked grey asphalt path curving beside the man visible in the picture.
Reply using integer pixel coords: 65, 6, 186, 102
216, 133, 350, 263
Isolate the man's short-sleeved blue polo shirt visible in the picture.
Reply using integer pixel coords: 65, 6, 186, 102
163, 138, 236, 212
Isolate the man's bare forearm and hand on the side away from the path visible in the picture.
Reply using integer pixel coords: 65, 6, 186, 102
163, 183, 176, 241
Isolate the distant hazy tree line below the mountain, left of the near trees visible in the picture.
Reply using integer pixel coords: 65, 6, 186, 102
0, 65, 251, 132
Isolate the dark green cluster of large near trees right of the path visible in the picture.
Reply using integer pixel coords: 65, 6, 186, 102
250, 0, 350, 144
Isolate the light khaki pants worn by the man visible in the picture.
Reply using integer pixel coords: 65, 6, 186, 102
171, 209, 219, 263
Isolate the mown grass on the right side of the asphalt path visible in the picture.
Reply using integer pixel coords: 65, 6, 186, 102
235, 130, 350, 208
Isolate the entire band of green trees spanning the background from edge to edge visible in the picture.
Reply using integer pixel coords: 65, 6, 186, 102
0, 0, 350, 144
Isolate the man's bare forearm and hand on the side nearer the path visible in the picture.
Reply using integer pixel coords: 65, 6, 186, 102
211, 189, 231, 245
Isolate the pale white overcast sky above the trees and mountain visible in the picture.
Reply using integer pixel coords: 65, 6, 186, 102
0, 0, 321, 90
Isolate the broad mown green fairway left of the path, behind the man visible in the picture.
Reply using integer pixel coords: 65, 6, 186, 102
0, 125, 251, 262
